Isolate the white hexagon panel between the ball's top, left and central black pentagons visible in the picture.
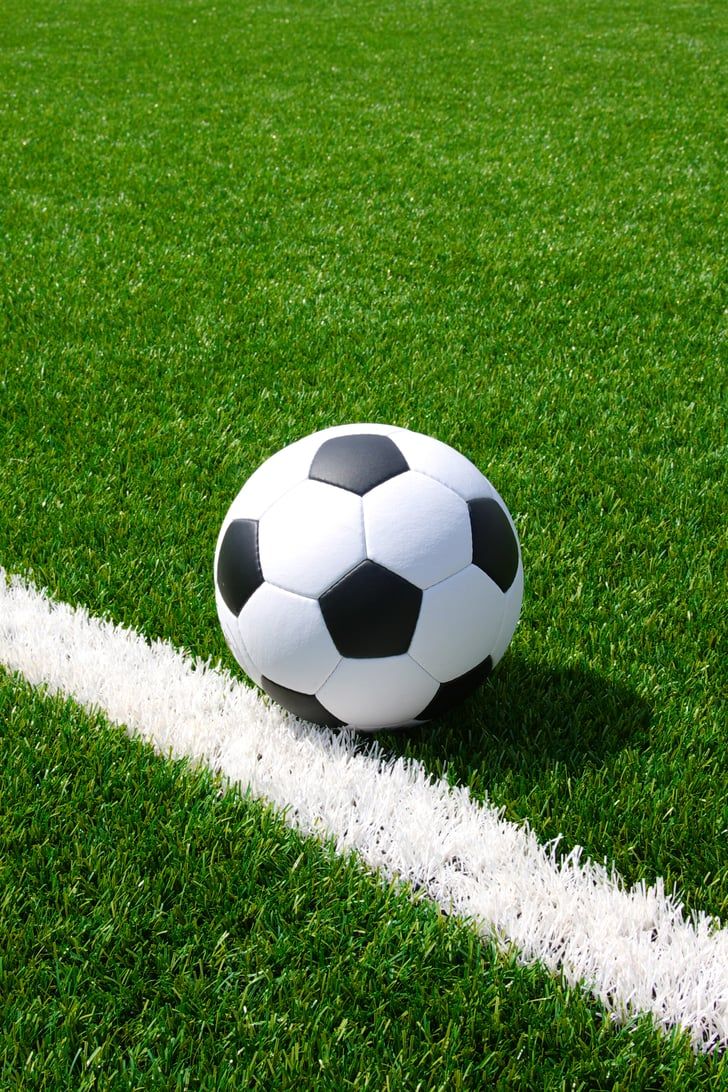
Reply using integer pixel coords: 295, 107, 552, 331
259, 480, 367, 596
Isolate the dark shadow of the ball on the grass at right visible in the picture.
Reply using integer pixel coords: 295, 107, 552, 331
380, 653, 652, 788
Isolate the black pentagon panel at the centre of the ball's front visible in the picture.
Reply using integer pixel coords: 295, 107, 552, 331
319, 561, 422, 660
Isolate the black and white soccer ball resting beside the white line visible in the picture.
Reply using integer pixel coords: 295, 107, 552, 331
214, 425, 523, 732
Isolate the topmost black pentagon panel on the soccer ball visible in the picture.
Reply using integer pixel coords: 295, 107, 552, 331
309, 432, 409, 497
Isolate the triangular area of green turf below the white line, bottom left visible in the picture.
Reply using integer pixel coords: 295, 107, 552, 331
0, 683, 728, 1092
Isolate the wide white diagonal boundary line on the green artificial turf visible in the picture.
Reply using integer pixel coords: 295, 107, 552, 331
0, 568, 728, 1049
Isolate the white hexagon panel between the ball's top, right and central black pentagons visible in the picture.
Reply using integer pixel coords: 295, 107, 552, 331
363, 471, 473, 587
